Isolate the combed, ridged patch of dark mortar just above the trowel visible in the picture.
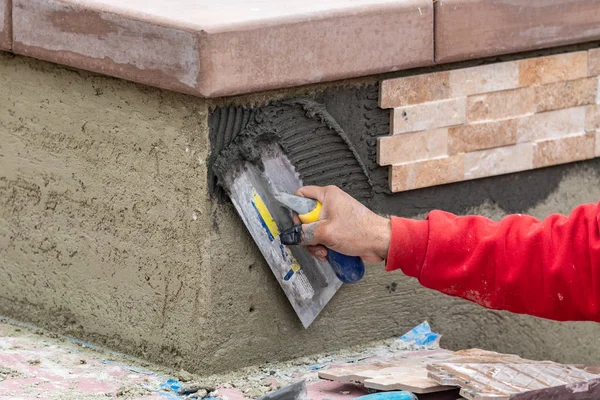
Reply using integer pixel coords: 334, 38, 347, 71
209, 98, 373, 200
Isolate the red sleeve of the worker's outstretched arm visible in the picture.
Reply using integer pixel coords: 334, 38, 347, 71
386, 204, 600, 322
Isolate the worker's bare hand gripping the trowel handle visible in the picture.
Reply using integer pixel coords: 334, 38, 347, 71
294, 186, 392, 263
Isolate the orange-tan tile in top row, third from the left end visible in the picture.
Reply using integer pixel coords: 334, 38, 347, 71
519, 51, 588, 86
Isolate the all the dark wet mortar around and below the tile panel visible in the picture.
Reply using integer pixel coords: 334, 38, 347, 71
209, 85, 572, 217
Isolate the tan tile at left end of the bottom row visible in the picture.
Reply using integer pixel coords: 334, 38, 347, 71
390, 154, 464, 192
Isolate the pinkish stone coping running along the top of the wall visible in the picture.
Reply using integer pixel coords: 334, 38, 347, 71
0, 0, 600, 97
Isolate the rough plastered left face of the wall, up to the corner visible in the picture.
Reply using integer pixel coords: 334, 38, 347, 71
0, 54, 211, 372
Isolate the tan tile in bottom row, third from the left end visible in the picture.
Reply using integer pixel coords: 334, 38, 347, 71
533, 133, 596, 168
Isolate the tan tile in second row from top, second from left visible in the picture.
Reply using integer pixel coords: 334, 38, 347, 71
467, 88, 535, 122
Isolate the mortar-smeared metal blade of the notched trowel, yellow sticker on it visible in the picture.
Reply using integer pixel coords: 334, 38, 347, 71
220, 143, 342, 328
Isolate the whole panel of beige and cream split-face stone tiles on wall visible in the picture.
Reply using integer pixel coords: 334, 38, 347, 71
377, 49, 600, 192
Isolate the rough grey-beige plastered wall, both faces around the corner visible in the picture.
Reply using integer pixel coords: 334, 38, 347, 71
0, 53, 600, 373
